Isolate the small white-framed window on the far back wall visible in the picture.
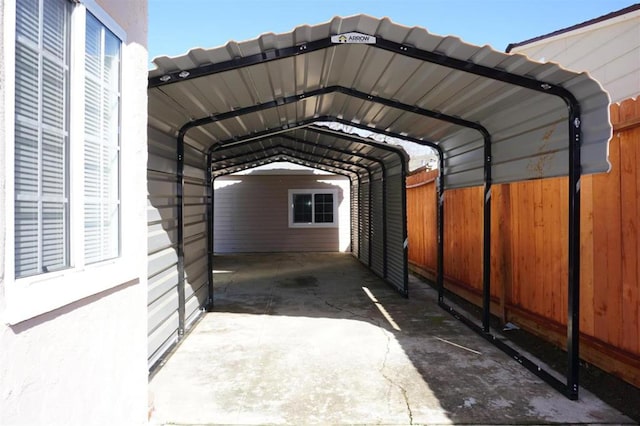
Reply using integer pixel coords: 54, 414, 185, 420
289, 189, 338, 228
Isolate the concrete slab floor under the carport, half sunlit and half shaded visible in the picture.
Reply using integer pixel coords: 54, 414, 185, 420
150, 253, 635, 425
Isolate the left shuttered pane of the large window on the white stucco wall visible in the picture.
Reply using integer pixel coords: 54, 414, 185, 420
14, 0, 71, 277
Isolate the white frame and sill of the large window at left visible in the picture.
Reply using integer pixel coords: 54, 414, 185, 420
2, 0, 134, 324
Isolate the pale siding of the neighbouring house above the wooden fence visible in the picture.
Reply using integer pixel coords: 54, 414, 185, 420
511, 10, 640, 103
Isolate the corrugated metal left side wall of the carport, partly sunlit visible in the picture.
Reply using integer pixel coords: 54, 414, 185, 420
147, 128, 208, 367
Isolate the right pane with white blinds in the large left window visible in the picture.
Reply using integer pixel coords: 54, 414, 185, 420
84, 13, 121, 263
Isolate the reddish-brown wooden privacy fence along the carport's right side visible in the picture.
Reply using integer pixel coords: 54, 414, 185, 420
407, 99, 640, 387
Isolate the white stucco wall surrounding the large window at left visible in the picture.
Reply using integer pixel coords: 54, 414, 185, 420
0, 0, 148, 425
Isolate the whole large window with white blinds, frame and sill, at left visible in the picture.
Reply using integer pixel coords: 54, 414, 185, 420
5, 0, 131, 321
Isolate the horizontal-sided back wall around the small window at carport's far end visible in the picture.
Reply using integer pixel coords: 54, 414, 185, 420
214, 174, 351, 253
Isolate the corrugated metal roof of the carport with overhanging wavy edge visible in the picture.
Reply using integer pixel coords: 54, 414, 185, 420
149, 15, 611, 188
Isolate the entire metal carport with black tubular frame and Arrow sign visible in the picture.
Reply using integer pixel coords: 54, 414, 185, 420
149, 15, 611, 398
